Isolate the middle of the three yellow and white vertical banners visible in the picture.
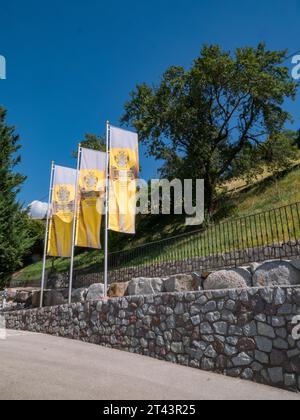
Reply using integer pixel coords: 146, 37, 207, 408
75, 149, 106, 249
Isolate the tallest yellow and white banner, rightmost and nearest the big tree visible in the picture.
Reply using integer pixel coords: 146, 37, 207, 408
109, 127, 139, 234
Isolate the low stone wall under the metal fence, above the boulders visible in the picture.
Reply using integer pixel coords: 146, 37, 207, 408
10, 241, 300, 289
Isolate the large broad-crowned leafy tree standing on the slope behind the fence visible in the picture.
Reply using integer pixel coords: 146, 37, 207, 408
122, 44, 297, 212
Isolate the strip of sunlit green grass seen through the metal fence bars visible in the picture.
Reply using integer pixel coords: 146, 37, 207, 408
111, 205, 300, 267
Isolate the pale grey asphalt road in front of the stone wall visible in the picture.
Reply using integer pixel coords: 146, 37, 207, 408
0, 331, 300, 401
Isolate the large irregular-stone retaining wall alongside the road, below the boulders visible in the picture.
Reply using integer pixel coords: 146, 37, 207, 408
5, 287, 300, 391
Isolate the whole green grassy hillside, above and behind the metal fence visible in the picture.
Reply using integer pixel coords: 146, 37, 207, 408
14, 167, 300, 281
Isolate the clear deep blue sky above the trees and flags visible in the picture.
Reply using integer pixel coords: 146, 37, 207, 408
0, 0, 300, 203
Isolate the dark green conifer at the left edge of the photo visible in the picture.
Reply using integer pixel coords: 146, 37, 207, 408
0, 107, 35, 286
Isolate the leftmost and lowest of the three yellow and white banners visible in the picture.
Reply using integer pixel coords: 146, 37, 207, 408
47, 166, 76, 257
